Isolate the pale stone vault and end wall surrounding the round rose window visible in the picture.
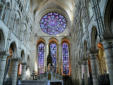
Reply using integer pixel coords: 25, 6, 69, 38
31, 0, 75, 36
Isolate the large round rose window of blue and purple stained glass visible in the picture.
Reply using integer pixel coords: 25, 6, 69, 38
40, 12, 66, 35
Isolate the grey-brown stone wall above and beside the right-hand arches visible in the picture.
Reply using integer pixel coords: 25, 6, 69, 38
70, 0, 107, 83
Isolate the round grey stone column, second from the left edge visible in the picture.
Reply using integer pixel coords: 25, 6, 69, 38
11, 58, 19, 85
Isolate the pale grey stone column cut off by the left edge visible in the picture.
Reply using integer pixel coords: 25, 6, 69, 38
0, 55, 7, 85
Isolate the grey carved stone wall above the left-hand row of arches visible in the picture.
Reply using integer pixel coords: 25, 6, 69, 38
0, 0, 35, 75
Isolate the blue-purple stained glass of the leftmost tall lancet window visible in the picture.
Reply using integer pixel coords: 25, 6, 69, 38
38, 43, 45, 73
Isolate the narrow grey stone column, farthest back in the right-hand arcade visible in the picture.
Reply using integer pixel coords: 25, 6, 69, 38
83, 60, 88, 85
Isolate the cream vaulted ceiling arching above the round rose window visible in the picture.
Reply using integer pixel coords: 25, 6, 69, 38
31, 0, 75, 21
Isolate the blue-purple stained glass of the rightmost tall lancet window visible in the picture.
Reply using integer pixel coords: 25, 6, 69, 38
62, 42, 69, 75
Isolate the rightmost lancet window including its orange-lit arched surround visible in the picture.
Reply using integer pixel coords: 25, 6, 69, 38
61, 38, 71, 76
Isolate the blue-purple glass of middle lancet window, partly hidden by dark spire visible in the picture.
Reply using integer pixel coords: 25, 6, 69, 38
50, 43, 57, 72
